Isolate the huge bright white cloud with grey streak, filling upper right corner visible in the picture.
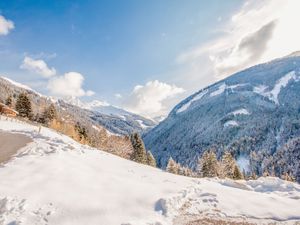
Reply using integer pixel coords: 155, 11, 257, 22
177, 0, 300, 82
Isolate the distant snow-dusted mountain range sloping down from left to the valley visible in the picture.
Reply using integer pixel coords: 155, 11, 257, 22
0, 77, 156, 135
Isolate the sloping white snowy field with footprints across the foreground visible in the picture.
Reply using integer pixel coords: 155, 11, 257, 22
0, 117, 300, 225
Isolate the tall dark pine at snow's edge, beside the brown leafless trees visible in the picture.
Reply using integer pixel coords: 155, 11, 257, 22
131, 133, 147, 164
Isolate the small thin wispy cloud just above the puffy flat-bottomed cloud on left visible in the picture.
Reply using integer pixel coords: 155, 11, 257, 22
20, 56, 56, 78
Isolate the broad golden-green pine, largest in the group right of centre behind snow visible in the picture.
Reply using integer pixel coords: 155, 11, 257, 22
199, 151, 219, 177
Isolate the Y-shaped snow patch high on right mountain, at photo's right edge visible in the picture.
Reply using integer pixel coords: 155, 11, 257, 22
253, 71, 299, 105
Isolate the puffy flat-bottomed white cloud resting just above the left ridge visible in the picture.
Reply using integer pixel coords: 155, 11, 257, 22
47, 72, 95, 97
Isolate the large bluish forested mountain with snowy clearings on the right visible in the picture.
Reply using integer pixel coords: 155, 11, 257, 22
144, 53, 300, 181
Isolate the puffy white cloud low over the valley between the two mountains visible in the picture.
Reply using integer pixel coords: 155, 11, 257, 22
124, 80, 184, 118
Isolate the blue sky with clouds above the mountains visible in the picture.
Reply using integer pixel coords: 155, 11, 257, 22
0, 0, 297, 117
